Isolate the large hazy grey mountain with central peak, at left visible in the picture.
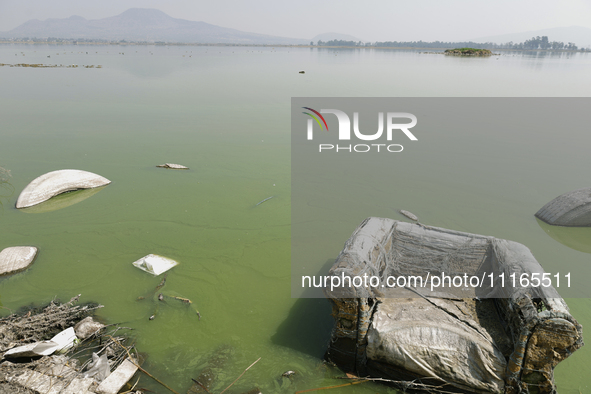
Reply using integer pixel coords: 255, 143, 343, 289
0, 8, 310, 45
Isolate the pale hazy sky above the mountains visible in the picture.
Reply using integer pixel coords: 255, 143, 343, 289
0, 0, 591, 41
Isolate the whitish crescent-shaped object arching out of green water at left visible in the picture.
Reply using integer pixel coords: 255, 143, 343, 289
16, 170, 111, 208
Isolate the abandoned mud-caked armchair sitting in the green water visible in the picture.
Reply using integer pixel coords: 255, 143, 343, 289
324, 217, 583, 393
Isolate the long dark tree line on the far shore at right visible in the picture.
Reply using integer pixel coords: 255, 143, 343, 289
310, 36, 591, 51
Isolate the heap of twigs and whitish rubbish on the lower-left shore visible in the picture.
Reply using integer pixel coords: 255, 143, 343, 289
0, 296, 138, 394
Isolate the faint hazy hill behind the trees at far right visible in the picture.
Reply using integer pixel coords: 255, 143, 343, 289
470, 26, 591, 48
